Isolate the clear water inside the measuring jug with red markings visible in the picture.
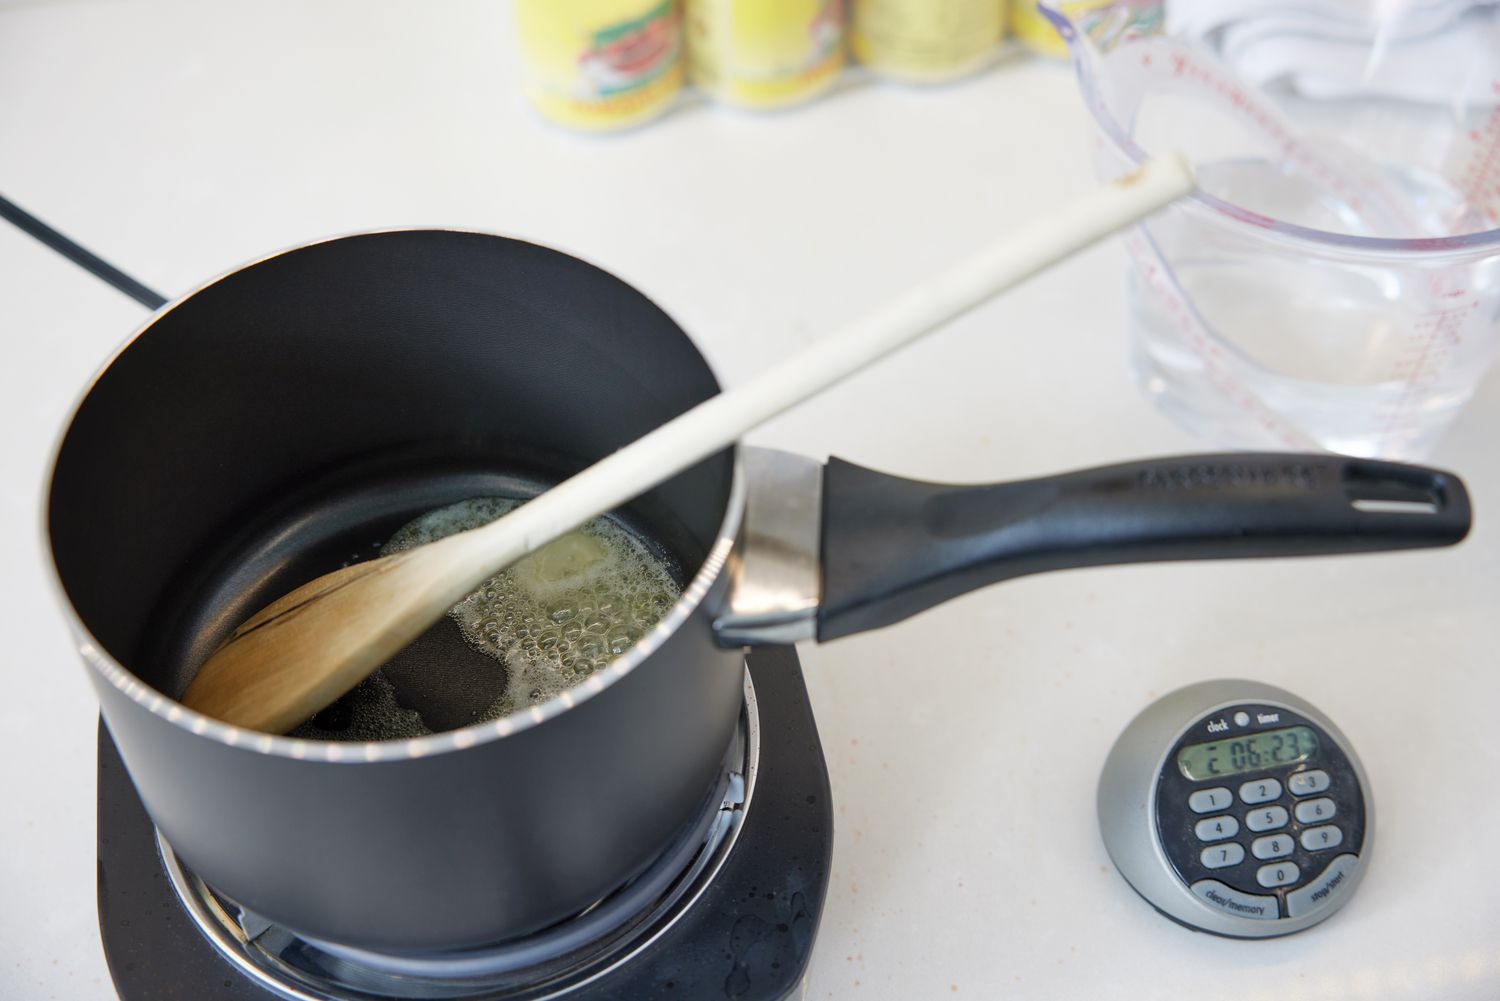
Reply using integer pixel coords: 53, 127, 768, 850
1131, 159, 1497, 458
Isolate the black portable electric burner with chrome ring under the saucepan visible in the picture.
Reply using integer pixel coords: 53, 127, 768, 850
99, 647, 833, 1001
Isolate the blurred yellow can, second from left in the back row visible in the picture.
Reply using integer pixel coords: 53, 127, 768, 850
687, 0, 845, 108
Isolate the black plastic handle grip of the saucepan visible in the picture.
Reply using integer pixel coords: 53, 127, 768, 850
818, 453, 1470, 641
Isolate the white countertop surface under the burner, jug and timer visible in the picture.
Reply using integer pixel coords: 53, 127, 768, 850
0, 0, 1500, 1001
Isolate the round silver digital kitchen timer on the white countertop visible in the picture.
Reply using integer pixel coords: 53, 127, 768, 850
1098, 680, 1374, 938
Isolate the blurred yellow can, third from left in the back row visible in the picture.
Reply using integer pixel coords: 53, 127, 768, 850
849, 0, 1005, 83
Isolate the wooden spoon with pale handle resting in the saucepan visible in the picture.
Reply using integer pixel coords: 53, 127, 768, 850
183, 156, 1193, 732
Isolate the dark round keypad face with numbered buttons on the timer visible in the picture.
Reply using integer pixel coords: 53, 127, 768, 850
1158, 713, 1364, 920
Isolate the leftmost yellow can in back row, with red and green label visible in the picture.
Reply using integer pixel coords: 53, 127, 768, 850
516, 0, 683, 131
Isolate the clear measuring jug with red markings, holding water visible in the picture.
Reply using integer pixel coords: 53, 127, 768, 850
1046, 5, 1500, 459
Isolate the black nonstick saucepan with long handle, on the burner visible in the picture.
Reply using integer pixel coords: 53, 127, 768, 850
47, 231, 1469, 953
